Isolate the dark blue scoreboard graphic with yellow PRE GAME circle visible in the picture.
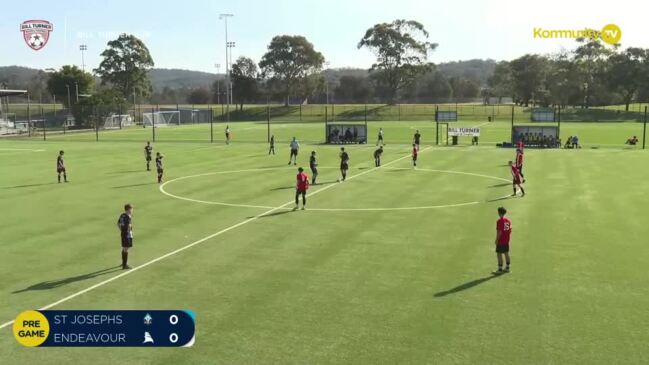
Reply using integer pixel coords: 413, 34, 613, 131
13, 310, 196, 347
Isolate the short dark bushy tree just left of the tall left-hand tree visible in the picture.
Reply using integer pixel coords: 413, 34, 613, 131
47, 65, 95, 106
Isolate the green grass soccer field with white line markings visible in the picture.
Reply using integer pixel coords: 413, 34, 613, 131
0, 122, 649, 364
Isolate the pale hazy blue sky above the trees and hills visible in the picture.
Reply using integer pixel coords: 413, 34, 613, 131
0, 0, 649, 72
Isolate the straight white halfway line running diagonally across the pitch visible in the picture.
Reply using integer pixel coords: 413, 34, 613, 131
0, 149, 426, 329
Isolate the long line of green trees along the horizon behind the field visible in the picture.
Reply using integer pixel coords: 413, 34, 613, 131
13, 19, 649, 122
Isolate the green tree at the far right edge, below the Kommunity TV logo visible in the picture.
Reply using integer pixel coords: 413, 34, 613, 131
607, 47, 649, 111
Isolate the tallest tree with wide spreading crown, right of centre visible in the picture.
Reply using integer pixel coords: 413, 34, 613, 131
357, 19, 437, 103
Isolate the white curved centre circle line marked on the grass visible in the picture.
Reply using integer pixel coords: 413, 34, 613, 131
160, 165, 510, 212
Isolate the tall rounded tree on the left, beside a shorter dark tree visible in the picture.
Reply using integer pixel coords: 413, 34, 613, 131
94, 34, 154, 99
